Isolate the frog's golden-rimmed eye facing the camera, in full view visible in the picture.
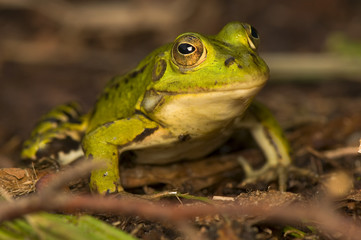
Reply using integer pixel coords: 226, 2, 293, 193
172, 35, 207, 68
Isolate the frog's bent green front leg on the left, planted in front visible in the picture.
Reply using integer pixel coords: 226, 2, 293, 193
83, 115, 166, 194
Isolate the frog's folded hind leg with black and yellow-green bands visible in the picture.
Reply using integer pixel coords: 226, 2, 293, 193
21, 103, 87, 165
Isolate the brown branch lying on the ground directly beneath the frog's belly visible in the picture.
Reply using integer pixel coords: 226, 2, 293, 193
121, 149, 263, 191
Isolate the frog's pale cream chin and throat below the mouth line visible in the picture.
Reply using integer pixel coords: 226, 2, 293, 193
152, 86, 261, 136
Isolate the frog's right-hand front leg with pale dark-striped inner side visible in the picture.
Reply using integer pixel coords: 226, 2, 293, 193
239, 102, 291, 191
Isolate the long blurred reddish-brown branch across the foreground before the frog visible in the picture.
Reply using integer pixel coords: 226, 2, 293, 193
0, 193, 361, 239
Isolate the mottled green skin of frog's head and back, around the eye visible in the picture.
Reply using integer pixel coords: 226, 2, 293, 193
87, 23, 269, 132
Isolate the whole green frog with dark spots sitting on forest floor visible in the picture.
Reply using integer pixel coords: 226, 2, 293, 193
21, 22, 291, 194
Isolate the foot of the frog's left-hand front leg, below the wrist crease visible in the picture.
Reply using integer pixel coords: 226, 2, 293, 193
90, 169, 124, 195
